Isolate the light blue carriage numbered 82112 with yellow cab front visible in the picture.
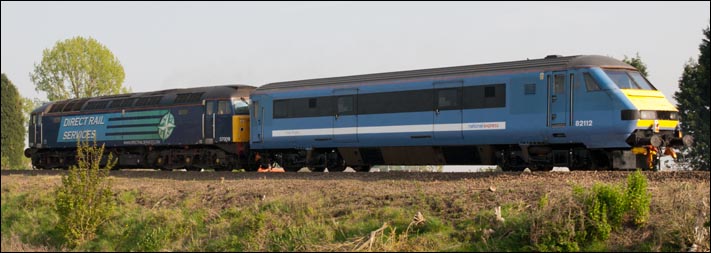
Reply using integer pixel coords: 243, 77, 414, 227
250, 55, 692, 171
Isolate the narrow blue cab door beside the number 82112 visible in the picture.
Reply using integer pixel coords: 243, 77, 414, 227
546, 71, 570, 128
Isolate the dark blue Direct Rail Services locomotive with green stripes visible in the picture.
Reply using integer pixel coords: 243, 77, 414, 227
25, 85, 255, 170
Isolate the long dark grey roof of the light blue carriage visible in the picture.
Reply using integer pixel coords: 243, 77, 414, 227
257, 55, 634, 91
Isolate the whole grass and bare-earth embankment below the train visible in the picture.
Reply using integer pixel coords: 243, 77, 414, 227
2, 171, 710, 251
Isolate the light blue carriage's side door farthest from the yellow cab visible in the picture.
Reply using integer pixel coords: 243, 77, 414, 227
333, 89, 358, 142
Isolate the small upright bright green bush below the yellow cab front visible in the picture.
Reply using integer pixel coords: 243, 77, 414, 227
625, 170, 652, 226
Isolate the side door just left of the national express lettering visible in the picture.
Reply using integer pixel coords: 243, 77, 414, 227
433, 81, 463, 140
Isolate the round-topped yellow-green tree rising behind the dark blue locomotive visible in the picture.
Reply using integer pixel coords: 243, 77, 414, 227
30, 37, 129, 101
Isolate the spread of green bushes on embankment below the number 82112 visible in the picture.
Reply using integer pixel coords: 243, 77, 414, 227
530, 171, 651, 252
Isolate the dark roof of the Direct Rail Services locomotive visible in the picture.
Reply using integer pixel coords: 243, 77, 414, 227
33, 84, 256, 113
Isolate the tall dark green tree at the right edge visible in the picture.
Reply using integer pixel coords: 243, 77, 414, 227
674, 26, 711, 170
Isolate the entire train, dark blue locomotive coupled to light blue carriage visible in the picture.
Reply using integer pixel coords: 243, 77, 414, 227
25, 55, 693, 172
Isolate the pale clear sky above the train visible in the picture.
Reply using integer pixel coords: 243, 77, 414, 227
0, 1, 711, 103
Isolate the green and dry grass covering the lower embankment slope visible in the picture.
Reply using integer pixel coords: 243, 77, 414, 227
2, 172, 709, 251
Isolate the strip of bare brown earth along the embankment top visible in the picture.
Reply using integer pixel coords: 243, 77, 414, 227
2, 171, 711, 215
